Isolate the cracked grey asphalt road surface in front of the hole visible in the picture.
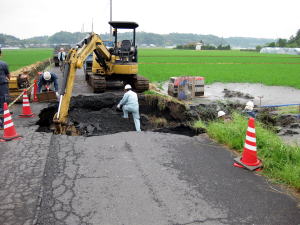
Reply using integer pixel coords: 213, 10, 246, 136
0, 67, 300, 225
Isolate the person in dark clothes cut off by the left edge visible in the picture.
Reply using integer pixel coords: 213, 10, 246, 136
0, 48, 10, 130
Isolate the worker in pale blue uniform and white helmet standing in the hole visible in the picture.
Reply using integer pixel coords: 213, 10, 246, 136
117, 84, 141, 131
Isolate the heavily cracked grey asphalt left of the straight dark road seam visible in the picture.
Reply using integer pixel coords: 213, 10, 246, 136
0, 133, 47, 225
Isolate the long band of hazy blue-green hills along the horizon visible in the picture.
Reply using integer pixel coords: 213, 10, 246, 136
0, 31, 276, 48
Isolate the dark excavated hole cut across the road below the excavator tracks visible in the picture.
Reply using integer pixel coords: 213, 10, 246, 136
37, 93, 205, 136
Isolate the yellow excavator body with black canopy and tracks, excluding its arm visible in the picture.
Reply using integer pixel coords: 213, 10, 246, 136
86, 21, 149, 92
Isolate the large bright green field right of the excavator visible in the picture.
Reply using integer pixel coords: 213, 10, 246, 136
139, 49, 300, 89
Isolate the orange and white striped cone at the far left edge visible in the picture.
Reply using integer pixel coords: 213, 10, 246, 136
0, 102, 22, 142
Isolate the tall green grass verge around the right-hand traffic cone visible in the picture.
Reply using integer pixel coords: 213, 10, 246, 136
194, 113, 300, 191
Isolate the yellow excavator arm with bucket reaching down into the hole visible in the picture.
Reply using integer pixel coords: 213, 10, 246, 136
53, 33, 115, 134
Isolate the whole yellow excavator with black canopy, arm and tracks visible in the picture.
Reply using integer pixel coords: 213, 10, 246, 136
53, 21, 149, 134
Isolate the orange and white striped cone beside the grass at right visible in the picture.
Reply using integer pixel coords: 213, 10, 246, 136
233, 117, 262, 171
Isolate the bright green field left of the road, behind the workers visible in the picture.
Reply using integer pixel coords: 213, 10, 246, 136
0, 48, 53, 71
